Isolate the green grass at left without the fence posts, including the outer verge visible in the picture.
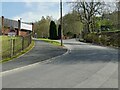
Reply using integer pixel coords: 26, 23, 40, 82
0, 36, 33, 62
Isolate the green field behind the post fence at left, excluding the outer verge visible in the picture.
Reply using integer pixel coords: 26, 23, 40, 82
0, 36, 30, 59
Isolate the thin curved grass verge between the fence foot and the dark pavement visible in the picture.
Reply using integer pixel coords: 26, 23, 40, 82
0, 41, 35, 63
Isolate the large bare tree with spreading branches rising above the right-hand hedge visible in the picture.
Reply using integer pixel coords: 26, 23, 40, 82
73, 0, 105, 33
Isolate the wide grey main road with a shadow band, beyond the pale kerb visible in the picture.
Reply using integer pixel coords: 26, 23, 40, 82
2, 39, 118, 88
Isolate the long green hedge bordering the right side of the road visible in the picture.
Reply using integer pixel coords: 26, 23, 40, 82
84, 32, 120, 47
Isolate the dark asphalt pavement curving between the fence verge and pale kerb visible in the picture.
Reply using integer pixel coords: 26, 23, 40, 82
2, 39, 67, 71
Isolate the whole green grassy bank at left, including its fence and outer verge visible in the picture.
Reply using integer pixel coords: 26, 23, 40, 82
0, 35, 34, 62
